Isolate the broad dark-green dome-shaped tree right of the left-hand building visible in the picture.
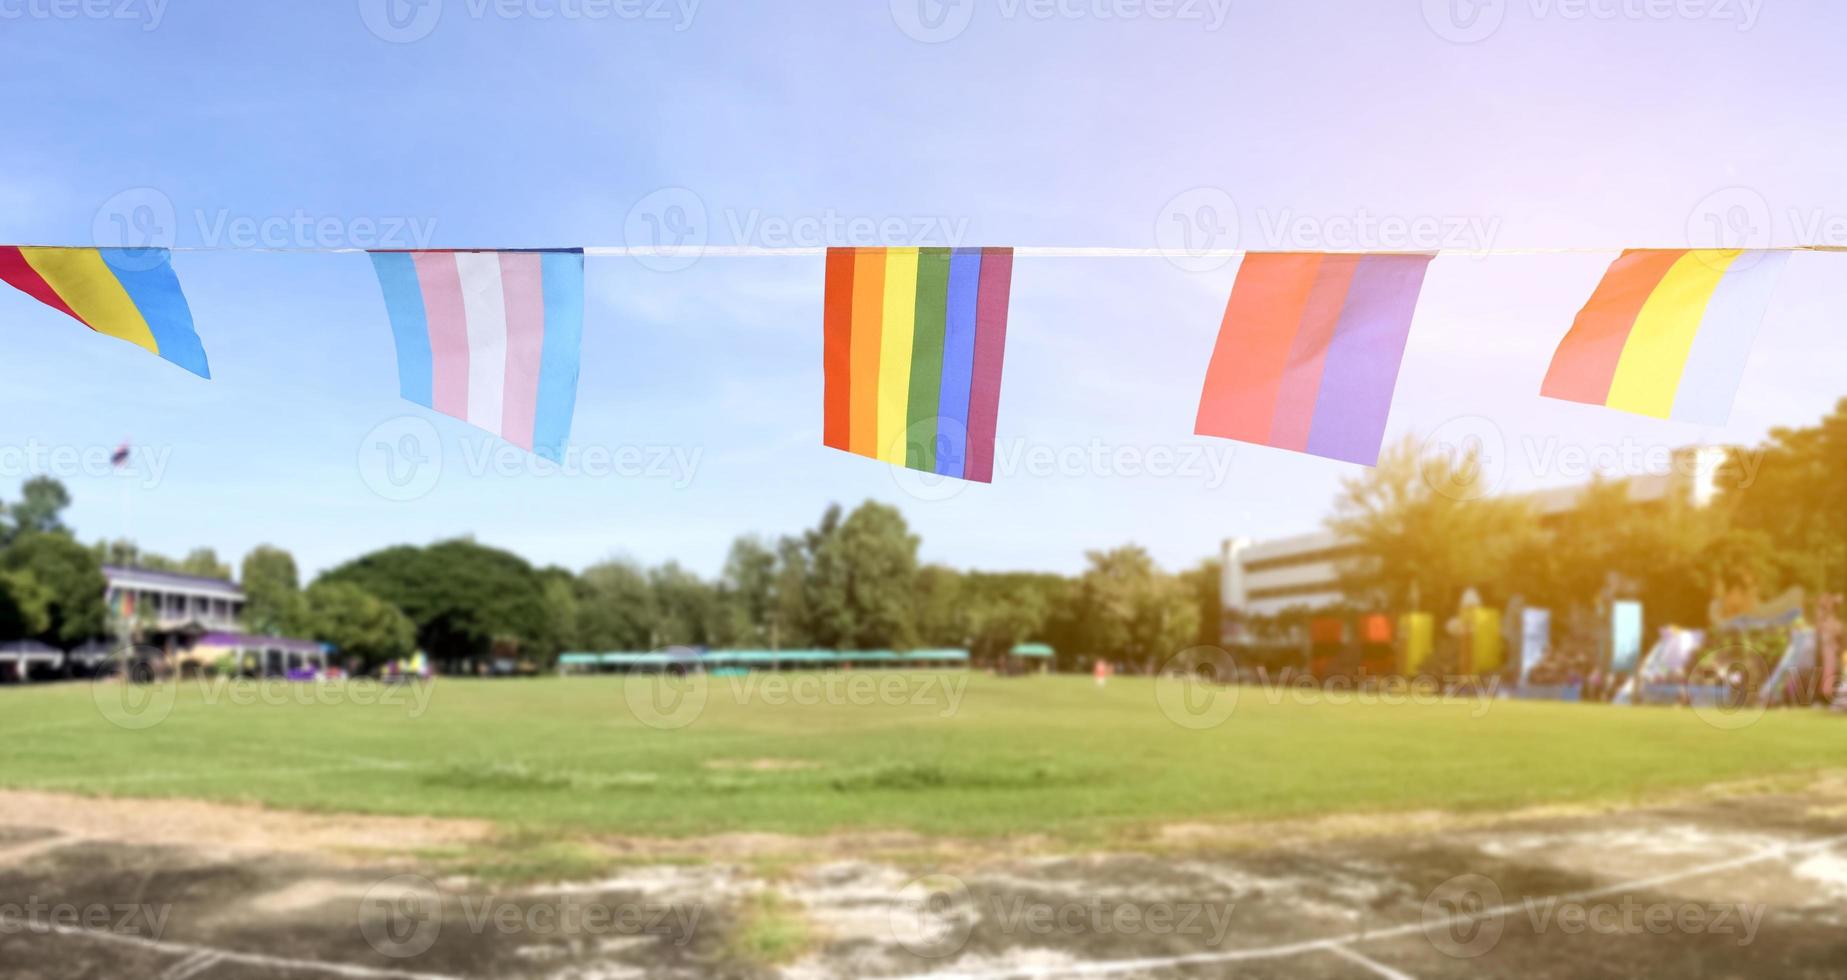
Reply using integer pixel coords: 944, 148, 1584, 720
318, 539, 556, 661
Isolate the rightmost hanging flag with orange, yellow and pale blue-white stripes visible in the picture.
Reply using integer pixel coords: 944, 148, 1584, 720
1539, 249, 1790, 426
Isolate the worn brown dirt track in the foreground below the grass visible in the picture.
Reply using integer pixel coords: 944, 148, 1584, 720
0, 784, 1847, 980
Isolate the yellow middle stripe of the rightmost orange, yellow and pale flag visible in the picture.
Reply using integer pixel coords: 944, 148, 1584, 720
1603, 249, 1744, 419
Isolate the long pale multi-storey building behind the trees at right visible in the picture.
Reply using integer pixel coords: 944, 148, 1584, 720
1219, 447, 1729, 627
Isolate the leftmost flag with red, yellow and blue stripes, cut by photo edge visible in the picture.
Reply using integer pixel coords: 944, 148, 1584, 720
0, 245, 212, 378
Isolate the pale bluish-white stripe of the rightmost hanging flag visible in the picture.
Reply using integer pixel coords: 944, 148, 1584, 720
1670, 251, 1790, 426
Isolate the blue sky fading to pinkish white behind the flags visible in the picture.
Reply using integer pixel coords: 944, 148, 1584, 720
0, 0, 1847, 572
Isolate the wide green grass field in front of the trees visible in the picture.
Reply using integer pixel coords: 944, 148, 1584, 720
0, 674, 1847, 842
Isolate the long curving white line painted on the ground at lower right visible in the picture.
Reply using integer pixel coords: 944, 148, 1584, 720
903, 834, 1847, 980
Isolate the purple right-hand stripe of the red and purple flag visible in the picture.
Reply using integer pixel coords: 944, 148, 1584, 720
1308, 255, 1431, 467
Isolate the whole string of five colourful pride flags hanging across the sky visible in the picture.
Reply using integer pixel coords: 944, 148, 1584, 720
0, 245, 1802, 484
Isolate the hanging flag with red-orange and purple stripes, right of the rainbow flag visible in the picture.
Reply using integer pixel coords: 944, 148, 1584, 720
1193, 253, 1433, 467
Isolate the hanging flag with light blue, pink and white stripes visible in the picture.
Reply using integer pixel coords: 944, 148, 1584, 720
371, 249, 584, 463
